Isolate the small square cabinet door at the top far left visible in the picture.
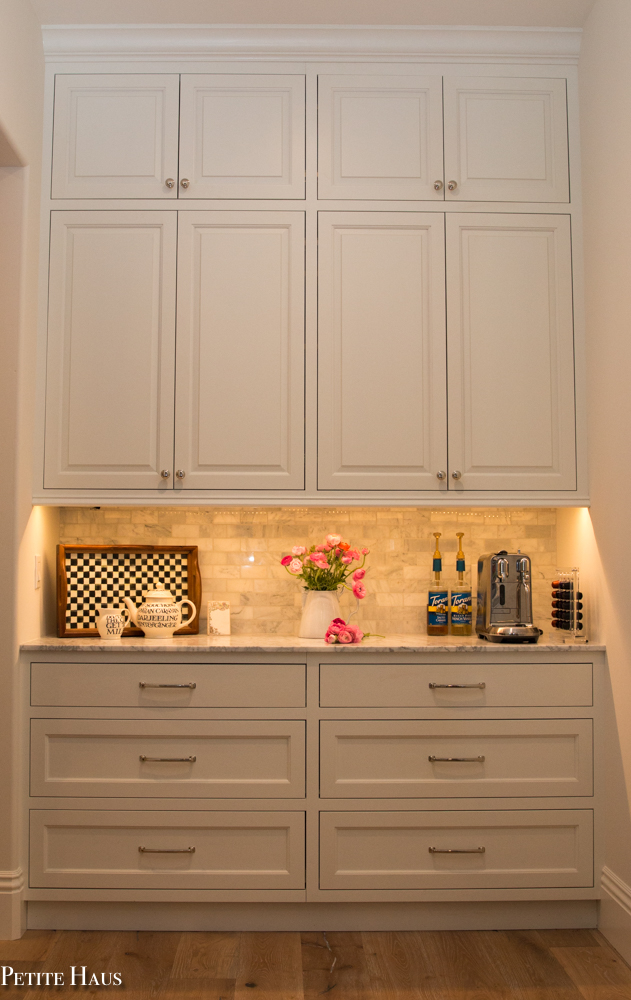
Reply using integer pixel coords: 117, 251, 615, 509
52, 73, 180, 198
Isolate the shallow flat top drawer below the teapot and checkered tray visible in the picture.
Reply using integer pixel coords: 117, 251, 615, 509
31, 663, 306, 708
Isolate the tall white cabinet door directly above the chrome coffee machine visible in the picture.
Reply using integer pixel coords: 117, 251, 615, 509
447, 213, 576, 493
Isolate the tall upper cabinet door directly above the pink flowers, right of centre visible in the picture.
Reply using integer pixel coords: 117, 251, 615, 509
318, 212, 447, 490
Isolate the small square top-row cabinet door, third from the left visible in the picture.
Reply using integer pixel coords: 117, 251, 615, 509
318, 75, 443, 200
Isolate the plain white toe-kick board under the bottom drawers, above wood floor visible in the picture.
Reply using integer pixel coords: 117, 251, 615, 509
28, 899, 598, 931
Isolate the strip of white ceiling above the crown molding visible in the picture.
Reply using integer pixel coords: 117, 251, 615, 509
31, 0, 594, 28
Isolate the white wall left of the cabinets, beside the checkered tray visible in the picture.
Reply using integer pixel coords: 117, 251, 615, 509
0, 0, 45, 938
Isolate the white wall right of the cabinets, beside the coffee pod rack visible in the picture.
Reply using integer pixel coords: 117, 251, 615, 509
579, 0, 631, 960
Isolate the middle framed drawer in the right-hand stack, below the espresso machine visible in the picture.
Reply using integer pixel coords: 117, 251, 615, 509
320, 719, 593, 798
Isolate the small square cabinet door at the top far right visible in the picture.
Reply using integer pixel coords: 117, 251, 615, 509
444, 76, 570, 201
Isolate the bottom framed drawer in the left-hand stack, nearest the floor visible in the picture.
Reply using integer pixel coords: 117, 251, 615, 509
30, 809, 305, 889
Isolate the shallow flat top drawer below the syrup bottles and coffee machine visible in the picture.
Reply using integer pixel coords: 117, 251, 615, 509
320, 661, 592, 708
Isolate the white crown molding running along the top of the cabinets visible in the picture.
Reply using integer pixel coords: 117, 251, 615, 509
42, 24, 582, 64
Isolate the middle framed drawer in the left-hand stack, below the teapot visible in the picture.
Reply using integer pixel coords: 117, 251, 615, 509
31, 719, 305, 798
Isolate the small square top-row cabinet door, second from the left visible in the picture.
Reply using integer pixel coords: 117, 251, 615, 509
179, 73, 305, 198
